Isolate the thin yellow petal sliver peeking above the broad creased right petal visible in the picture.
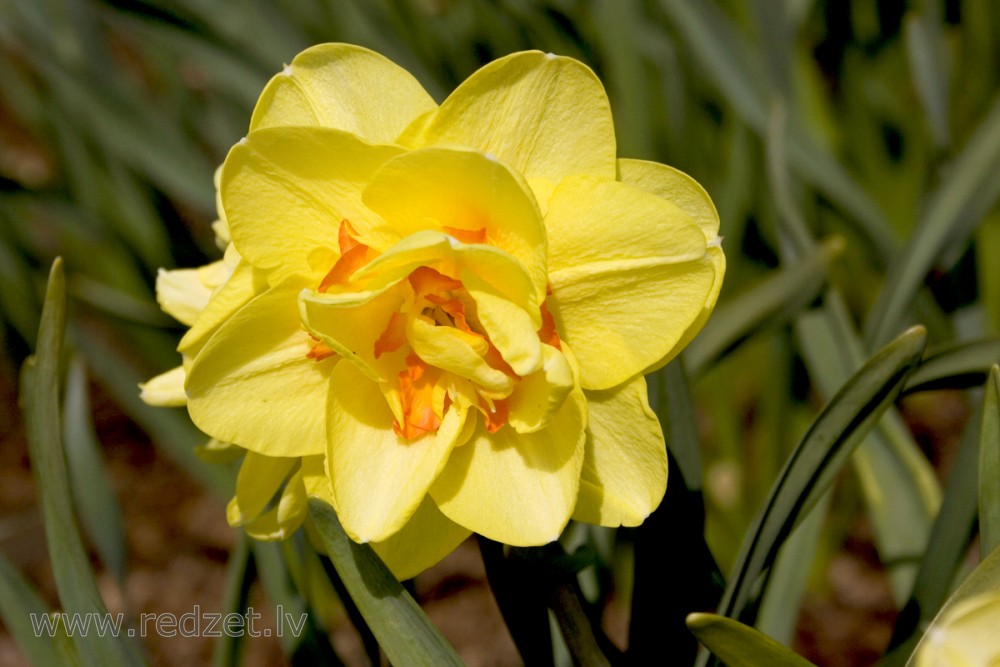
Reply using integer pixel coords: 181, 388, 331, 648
618, 159, 719, 241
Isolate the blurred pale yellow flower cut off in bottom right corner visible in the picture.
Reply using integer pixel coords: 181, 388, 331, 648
916, 592, 1000, 667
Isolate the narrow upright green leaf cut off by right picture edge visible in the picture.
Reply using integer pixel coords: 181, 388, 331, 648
979, 366, 1000, 558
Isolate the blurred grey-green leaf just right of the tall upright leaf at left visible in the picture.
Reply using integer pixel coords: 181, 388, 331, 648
63, 356, 125, 583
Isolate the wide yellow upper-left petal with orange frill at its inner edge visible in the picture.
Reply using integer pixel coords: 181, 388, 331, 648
221, 127, 401, 284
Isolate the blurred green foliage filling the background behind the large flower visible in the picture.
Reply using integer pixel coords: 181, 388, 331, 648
0, 0, 1000, 664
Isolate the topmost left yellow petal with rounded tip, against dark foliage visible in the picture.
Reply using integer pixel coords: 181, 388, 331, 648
250, 44, 437, 143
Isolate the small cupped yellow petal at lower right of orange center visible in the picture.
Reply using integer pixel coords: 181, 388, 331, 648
507, 345, 574, 433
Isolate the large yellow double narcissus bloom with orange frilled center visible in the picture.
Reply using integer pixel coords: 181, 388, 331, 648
145, 44, 725, 576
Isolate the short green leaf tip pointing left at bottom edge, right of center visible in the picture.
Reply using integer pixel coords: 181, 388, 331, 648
687, 613, 815, 667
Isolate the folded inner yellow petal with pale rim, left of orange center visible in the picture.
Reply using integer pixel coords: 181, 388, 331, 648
298, 286, 403, 382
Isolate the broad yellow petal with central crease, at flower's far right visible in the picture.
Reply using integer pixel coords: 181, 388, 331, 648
545, 177, 715, 389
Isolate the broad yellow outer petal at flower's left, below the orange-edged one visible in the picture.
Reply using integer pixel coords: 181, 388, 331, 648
186, 284, 336, 456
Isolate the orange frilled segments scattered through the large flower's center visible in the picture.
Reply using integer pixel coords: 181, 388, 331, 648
306, 220, 561, 440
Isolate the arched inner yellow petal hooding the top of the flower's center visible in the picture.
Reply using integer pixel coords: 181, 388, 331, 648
364, 147, 546, 299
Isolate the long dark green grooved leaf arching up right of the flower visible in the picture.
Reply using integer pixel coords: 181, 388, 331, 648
719, 327, 926, 618
